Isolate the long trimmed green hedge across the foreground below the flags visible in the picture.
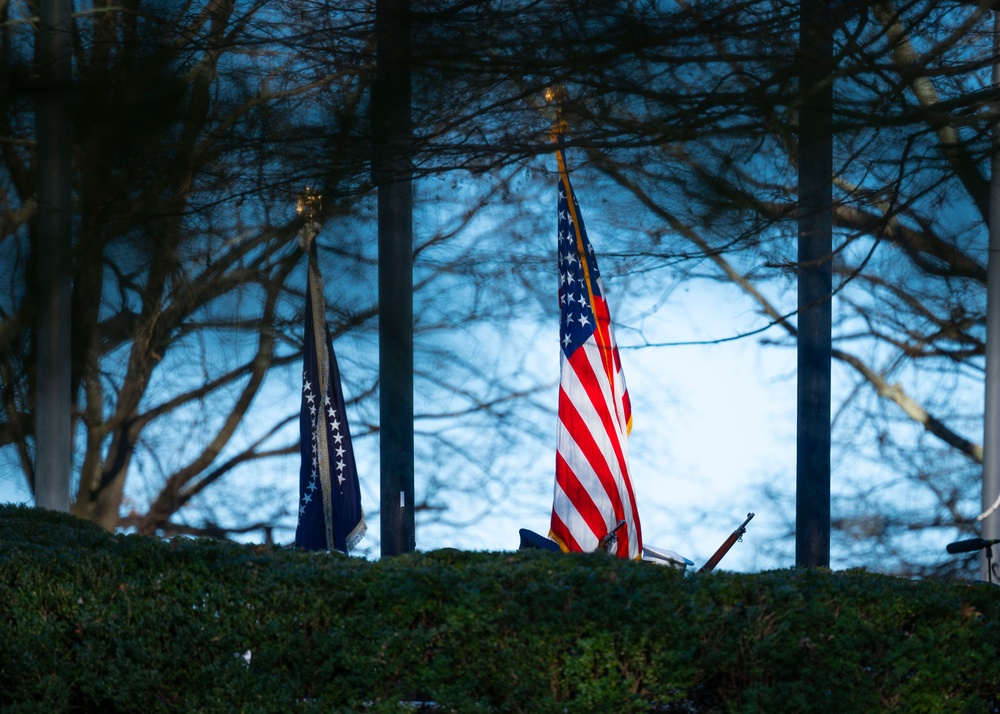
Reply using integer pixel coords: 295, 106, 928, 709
0, 506, 1000, 714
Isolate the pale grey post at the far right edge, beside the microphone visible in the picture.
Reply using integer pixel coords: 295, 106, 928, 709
980, 10, 1000, 582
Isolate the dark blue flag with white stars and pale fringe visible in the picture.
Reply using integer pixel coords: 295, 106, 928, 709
295, 234, 365, 553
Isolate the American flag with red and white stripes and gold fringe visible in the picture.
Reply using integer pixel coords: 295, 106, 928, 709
549, 149, 642, 559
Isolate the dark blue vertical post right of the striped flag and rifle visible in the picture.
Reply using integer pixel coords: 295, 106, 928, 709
795, 0, 833, 567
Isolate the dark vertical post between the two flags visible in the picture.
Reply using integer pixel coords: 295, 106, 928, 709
372, 0, 416, 556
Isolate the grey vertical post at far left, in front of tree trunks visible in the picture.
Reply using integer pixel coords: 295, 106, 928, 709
34, 0, 72, 512
